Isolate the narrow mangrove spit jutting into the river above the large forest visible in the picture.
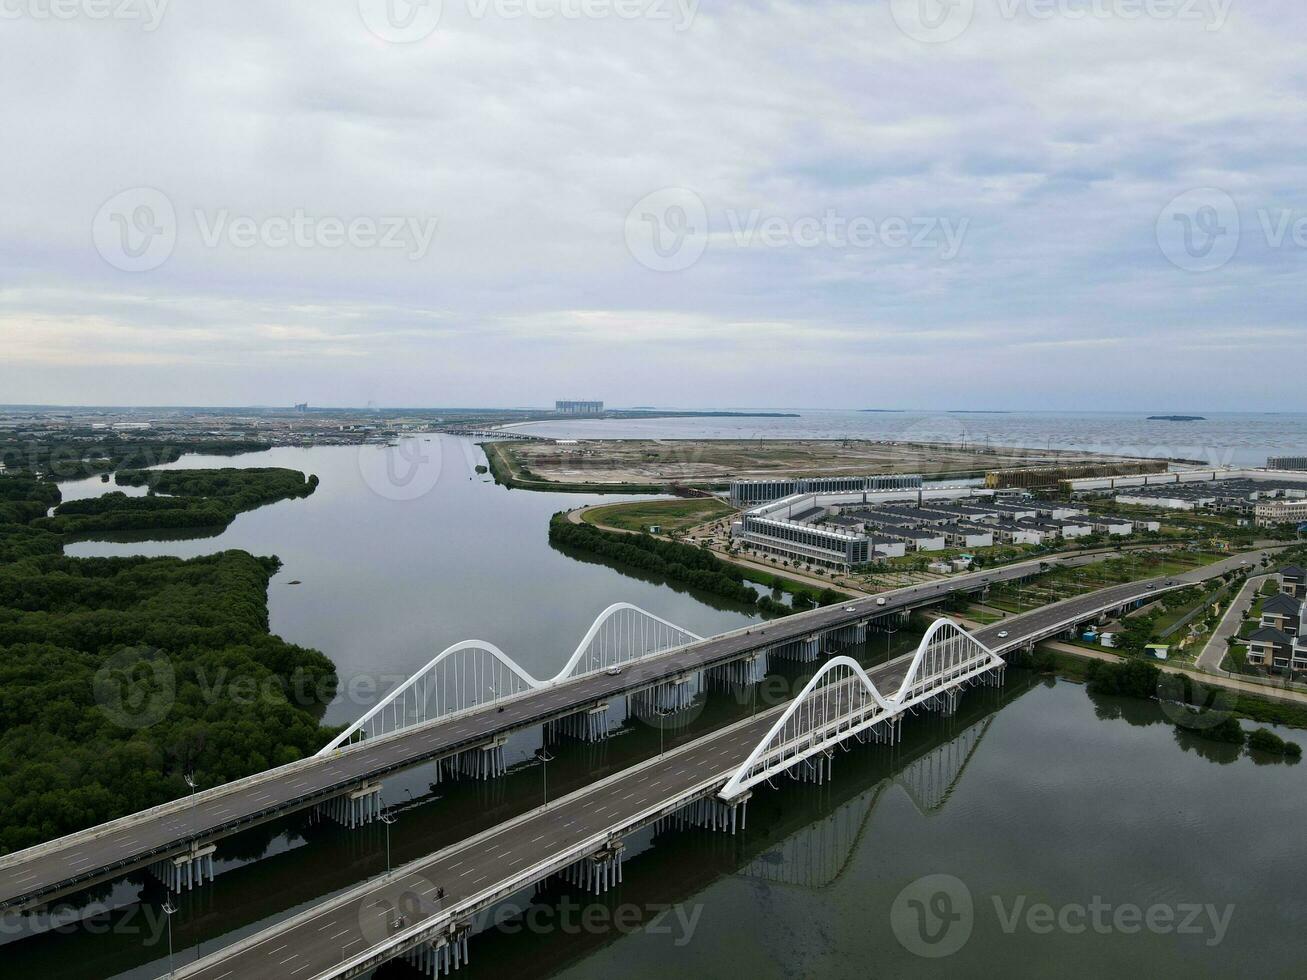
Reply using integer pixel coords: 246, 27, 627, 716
35, 468, 318, 534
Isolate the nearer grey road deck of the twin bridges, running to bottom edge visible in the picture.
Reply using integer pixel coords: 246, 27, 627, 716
176, 558, 1265, 980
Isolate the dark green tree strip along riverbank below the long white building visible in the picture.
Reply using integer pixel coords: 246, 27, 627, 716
549, 514, 847, 614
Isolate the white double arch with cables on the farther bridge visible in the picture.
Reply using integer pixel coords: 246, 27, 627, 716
318, 602, 703, 757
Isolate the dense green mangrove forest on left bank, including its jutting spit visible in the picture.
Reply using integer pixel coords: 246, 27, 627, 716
0, 470, 336, 853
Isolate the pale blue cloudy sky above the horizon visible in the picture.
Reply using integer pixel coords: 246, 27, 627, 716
0, 0, 1307, 410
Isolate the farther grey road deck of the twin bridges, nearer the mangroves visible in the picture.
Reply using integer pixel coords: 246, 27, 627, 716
0, 546, 1256, 909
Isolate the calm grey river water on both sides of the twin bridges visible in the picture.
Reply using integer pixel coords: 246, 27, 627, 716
12, 438, 1307, 980
